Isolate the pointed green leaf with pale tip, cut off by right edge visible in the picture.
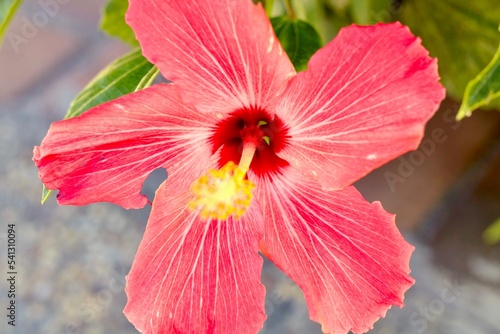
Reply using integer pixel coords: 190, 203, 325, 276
457, 34, 500, 121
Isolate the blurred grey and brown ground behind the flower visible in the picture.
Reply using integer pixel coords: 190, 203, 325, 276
0, 0, 500, 334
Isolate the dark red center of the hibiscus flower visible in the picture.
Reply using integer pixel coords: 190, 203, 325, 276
210, 107, 289, 176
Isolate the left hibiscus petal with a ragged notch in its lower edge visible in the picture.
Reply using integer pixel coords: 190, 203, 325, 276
33, 85, 217, 208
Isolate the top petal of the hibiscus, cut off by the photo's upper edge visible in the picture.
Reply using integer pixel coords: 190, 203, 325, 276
127, 0, 295, 113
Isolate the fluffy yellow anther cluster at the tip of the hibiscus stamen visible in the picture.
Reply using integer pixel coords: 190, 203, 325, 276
189, 161, 255, 220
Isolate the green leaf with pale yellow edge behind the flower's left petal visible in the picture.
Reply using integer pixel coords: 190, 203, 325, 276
42, 49, 159, 204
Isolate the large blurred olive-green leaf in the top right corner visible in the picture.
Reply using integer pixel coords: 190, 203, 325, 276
395, 0, 500, 107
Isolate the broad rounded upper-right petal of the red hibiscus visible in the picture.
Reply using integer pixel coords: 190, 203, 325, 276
276, 23, 445, 190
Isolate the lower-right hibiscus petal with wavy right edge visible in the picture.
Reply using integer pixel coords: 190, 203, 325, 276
256, 167, 413, 334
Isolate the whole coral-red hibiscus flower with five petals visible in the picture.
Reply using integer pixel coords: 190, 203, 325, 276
34, 0, 444, 333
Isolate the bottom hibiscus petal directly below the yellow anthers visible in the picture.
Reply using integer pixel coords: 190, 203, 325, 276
124, 175, 265, 334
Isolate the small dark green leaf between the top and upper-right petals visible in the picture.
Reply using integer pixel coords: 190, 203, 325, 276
271, 16, 322, 71
